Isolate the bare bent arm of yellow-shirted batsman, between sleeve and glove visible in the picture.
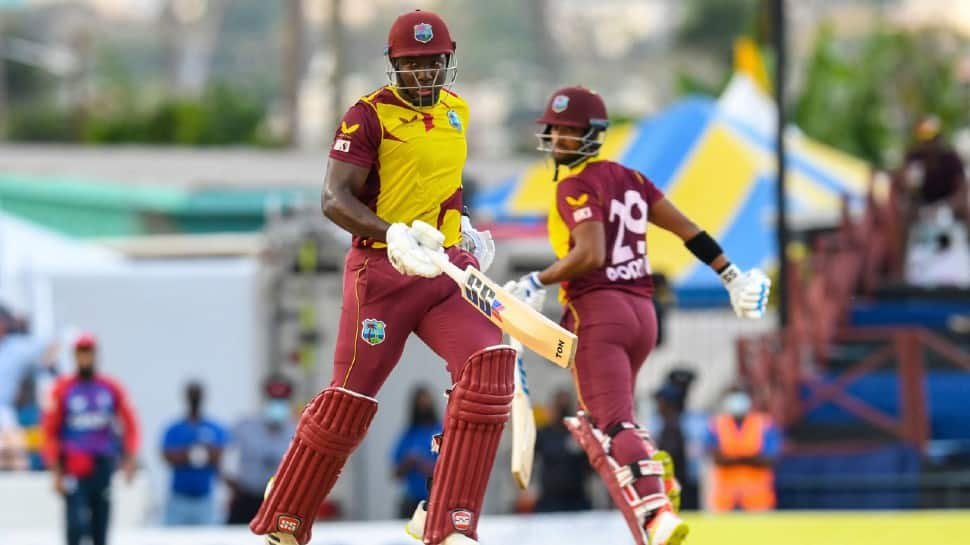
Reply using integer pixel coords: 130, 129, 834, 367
322, 158, 391, 242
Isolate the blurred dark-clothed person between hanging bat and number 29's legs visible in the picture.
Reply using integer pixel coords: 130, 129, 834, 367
535, 389, 592, 512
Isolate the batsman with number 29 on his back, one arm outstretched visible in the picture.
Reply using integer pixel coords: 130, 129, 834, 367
506, 87, 770, 545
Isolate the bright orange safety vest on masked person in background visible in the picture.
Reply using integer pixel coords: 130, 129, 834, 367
710, 412, 775, 512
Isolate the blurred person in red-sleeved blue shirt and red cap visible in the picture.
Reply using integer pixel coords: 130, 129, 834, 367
44, 334, 138, 545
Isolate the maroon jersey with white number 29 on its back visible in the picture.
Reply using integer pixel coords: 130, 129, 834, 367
548, 158, 664, 301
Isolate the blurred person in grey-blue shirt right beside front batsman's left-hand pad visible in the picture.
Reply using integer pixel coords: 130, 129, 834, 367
226, 378, 296, 524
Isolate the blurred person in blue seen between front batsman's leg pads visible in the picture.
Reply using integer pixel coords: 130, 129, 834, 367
392, 386, 441, 518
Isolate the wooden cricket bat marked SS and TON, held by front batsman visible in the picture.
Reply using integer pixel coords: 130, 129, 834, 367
428, 252, 576, 368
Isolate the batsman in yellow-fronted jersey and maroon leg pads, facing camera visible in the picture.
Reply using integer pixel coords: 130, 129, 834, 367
250, 11, 506, 545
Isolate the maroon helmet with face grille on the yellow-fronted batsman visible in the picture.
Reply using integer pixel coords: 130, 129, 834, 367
384, 10, 458, 99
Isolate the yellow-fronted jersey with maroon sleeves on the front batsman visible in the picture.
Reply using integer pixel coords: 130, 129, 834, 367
330, 86, 468, 247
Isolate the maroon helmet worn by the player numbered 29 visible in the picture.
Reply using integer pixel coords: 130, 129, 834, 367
536, 85, 610, 166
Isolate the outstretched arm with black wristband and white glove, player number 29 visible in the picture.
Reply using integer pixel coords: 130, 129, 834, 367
649, 198, 771, 318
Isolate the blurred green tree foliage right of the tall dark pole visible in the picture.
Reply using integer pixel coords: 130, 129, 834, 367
793, 28, 970, 167
